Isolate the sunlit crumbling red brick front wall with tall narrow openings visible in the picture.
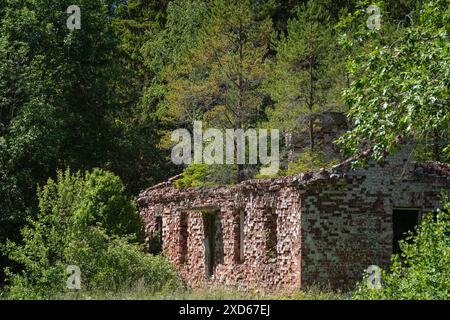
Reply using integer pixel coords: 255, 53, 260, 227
139, 179, 300, 289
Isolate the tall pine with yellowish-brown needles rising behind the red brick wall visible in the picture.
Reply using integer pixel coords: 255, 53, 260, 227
164, 1, 272, 181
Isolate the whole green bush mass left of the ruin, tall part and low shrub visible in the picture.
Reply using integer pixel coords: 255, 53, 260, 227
4, 169, 178, 299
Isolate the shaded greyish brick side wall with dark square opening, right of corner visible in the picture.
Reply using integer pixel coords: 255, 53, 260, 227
301, 148, 450, 288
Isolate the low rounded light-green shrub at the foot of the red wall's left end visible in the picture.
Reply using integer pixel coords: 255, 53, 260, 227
65, 227, 178, 291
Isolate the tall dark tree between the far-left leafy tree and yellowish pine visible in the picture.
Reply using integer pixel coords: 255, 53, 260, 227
107, 0, 179, 194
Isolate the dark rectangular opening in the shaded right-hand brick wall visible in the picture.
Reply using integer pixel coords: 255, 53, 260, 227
392, 209, 420, 253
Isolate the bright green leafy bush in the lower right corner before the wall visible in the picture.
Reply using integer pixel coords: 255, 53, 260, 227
354, 196, 450, 300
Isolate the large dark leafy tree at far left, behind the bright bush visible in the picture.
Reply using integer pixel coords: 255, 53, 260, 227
0, 0, 123, 278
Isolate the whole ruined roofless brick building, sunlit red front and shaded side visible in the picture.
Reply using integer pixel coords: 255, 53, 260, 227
138, 149, 450, 290
